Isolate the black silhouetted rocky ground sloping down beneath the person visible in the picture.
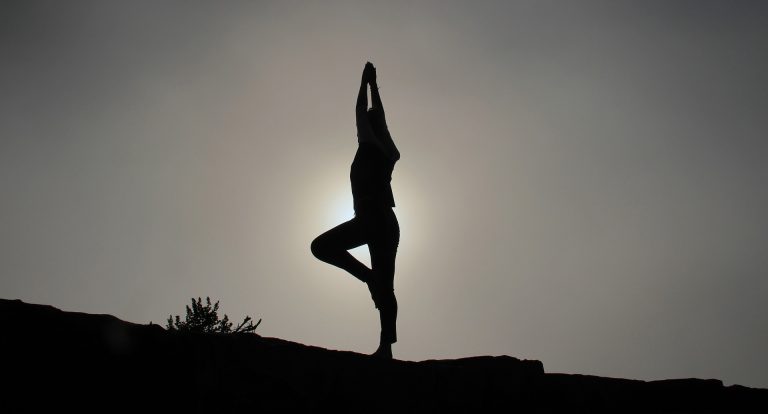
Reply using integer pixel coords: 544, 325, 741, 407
0, 299, 768, 413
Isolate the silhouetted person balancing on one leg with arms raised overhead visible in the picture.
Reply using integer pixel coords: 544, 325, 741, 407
312, 62, 400, 359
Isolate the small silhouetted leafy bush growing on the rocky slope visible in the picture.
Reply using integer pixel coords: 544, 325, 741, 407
166, 297, 261, 333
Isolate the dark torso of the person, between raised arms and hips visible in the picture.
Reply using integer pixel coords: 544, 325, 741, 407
349, 142, 395, 213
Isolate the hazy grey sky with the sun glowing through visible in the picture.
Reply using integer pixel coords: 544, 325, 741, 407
0, 0, 768, 387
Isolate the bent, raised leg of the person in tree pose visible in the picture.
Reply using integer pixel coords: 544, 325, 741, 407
311, 218, 371, 283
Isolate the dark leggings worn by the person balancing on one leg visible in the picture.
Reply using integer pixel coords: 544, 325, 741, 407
311, 208, 400, 344
